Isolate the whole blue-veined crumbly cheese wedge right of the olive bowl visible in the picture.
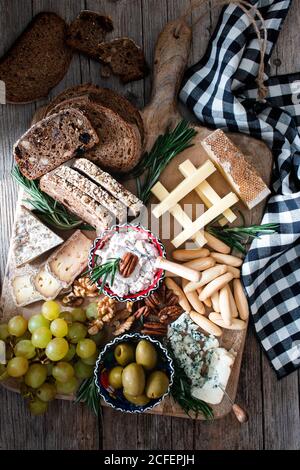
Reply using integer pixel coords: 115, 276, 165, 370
168, 313, 235, 405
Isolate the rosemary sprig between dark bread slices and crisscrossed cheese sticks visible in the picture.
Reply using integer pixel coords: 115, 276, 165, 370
131, 120, 197, 204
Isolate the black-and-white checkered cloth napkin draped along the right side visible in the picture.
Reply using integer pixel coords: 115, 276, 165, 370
180, 0, 300, 378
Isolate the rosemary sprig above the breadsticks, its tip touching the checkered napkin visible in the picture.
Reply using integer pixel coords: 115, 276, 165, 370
206, 224, 278, 254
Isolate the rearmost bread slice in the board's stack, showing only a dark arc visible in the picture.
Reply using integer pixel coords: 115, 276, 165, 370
45, 83, 144, 142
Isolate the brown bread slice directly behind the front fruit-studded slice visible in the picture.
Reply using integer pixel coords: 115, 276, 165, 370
49, 97, 141, 173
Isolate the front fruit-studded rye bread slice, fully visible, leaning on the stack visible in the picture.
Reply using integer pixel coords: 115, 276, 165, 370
14, 109, 99, 180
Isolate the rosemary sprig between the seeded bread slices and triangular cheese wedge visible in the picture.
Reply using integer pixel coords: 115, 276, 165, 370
11, 165, 94, 230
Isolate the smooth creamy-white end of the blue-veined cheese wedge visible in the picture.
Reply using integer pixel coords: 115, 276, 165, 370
191, 348, 235, 405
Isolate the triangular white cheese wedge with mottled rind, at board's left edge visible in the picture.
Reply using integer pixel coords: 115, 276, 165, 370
13, 206, 63, 267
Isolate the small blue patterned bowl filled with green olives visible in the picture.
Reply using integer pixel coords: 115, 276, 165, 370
94, 333, 174, 413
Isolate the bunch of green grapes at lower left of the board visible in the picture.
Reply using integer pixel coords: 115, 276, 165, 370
0, 300, 102, 415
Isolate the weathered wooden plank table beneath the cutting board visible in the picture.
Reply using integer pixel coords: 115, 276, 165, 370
0, 0, 300, 450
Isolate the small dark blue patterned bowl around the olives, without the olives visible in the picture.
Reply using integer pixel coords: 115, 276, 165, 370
94, 333, 174, 413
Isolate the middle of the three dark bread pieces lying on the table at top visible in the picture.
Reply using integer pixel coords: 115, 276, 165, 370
67, 10, 114, 59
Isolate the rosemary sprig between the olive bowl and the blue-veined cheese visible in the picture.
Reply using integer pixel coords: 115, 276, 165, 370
167, 344, 214, 420
